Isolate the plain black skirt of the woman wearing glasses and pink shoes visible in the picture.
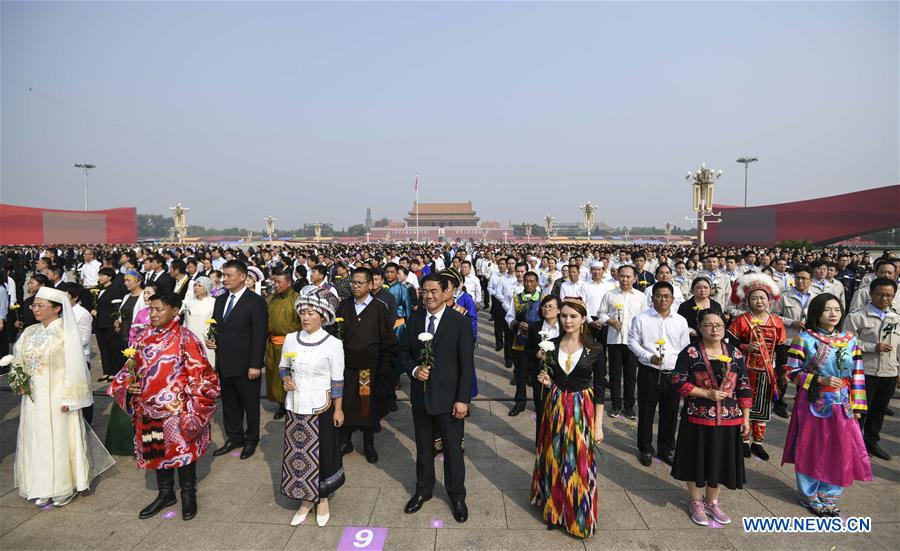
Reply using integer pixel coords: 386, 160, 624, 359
672, 414, 747, 490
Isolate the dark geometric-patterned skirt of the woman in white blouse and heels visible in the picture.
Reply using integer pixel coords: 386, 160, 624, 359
281, 406, 344, 503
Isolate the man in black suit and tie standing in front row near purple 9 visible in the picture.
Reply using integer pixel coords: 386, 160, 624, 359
404, 274, 475, 522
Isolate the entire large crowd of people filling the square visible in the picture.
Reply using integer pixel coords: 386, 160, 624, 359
0, 242, 900, 538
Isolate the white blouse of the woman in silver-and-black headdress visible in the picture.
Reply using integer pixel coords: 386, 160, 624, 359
278, 328, 344, 415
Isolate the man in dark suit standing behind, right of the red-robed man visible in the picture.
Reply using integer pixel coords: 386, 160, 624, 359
206, 260, 269, 459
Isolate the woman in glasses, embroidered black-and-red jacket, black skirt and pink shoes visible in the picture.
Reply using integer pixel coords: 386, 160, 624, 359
672, 310, 753, 526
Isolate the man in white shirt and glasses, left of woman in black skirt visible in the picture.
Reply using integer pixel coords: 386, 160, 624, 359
628, 281, 691, 467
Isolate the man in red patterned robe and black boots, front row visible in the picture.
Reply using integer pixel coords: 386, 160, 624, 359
106, 293, 220, 520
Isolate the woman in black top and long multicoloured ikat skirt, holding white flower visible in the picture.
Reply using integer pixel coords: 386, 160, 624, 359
531, 301, 606, 538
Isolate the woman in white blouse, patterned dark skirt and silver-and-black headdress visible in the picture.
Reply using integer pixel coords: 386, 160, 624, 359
279, 289, 344, 526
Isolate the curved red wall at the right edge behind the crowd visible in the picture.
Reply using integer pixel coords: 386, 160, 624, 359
706, 185, 900, 245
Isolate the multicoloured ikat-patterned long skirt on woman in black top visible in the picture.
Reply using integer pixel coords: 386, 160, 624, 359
531, 385, 597, 538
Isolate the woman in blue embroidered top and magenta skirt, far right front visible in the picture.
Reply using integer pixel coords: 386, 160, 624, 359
781, 293, 872, 516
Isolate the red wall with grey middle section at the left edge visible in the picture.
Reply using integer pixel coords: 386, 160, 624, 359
0, 204, 137, 245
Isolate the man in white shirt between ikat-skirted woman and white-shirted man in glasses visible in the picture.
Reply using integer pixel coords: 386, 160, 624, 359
599, 264, 647, 419
